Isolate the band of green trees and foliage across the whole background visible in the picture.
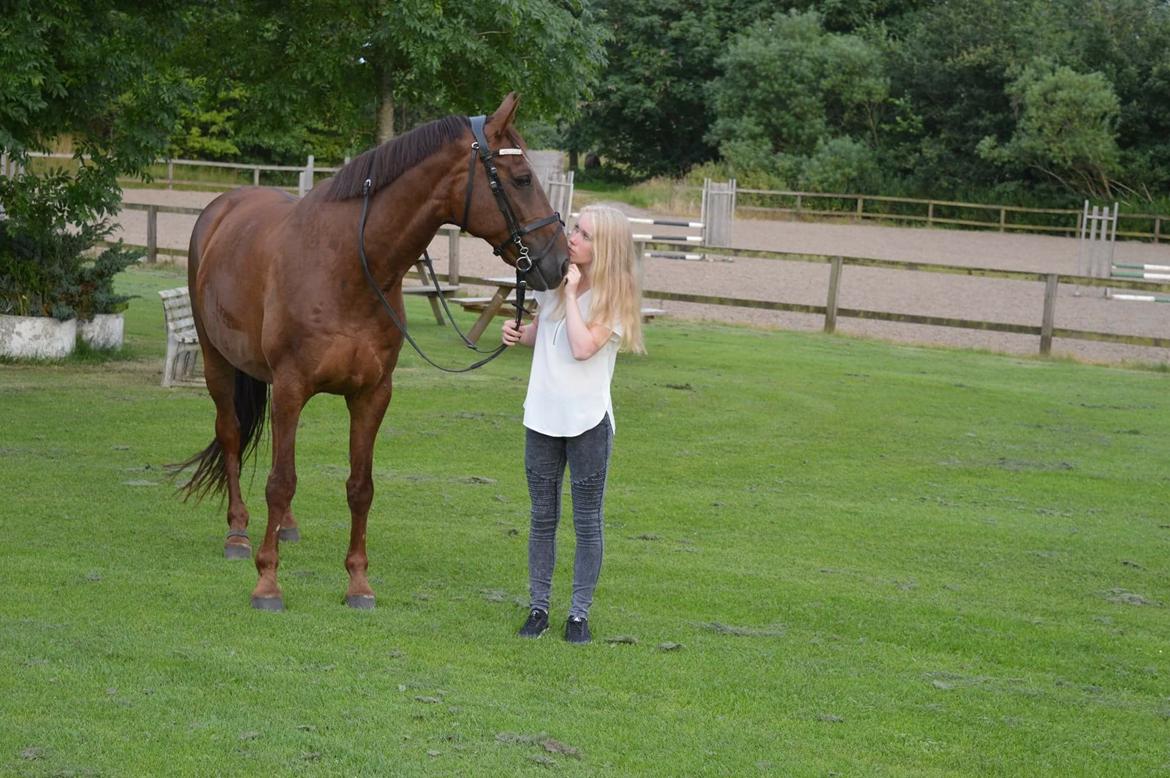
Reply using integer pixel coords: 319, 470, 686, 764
0, 0, 1170, 216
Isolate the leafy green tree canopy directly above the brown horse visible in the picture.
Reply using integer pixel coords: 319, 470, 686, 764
171, 0, 606, 157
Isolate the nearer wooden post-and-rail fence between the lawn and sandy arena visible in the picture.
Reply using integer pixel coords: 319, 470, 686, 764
111, 202, 1170, 354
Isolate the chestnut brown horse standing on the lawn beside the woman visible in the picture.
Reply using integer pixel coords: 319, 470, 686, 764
179, 92, 569, 611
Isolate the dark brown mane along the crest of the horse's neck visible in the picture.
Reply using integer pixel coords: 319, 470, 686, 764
325, 116, 470, 200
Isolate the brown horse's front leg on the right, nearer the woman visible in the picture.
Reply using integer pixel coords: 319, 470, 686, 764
345, 380, 391, 608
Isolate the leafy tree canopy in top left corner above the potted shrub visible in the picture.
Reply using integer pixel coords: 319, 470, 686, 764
0, 0, 187, 220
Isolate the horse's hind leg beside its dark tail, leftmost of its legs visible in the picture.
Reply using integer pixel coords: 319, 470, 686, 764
204, 347, 252, 559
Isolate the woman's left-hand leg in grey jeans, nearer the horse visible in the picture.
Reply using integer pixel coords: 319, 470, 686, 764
524, 427, 565, 613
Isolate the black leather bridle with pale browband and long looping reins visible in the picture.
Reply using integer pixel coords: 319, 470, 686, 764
358, 116, 565, 373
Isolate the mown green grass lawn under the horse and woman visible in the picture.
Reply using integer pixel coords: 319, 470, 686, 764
0, 264, 1170, 776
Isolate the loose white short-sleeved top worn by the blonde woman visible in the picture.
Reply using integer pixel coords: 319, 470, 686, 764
524, 289, 621, 438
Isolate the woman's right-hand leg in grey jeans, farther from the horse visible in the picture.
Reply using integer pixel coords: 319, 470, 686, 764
566, 415, 613, 619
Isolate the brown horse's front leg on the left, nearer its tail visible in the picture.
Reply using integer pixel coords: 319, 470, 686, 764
252, 379, 308, 611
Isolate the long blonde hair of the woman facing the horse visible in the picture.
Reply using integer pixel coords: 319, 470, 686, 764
557, 205, 646, 353
